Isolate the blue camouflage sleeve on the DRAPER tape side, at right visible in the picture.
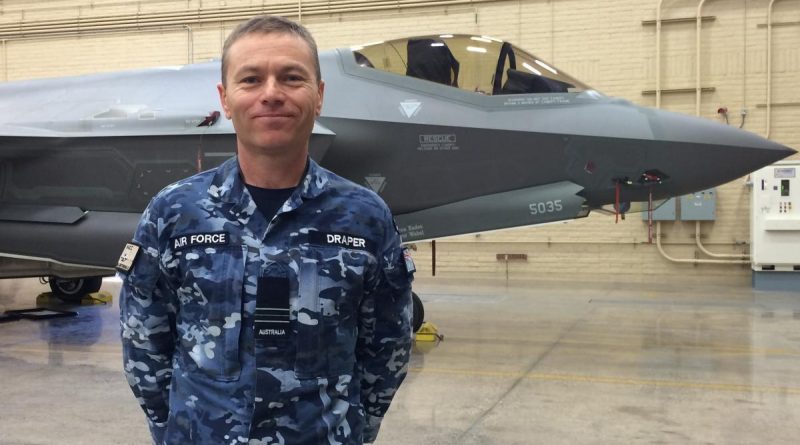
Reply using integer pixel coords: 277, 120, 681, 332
356, 212, 412, 443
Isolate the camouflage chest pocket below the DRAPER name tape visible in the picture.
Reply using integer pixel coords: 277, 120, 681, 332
291, 246, 375, 378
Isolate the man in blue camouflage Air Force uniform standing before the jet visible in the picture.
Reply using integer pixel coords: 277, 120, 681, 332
118, 17, 413, 445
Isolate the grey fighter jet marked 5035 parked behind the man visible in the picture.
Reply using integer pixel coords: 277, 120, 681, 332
0, 35, 794, 302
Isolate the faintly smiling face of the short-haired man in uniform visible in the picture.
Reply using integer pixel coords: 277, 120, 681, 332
217, 33, 324, 155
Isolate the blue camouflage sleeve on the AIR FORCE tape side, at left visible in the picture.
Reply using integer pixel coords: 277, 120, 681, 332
119, 204, 175, 444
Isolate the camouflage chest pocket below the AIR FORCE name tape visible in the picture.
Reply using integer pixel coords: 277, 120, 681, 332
175, 246, 246, 381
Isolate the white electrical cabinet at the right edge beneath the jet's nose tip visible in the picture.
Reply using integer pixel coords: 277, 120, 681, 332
750, 161, 800, 271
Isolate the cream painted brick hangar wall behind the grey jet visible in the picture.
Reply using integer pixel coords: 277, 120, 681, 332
0, 0, 800, 285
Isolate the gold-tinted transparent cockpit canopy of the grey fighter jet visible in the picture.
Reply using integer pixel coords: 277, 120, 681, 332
352, 34, 589, 95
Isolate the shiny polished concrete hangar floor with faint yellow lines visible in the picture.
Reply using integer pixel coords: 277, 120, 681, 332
0, 279, 800, 445
